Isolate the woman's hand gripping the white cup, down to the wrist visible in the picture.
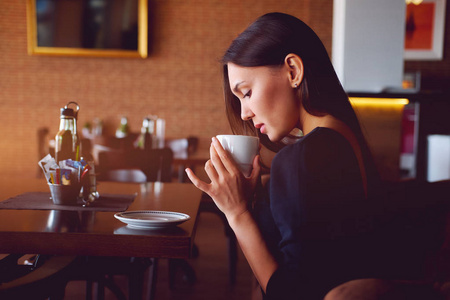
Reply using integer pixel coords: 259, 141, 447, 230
186, 137, 260, 219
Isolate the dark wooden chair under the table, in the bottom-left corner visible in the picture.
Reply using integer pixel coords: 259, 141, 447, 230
0, 254, 76, 300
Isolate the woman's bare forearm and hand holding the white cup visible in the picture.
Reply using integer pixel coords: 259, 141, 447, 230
186, 138, 278, 292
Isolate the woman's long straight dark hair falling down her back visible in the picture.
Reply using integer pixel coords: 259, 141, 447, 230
222, 13, 372, 176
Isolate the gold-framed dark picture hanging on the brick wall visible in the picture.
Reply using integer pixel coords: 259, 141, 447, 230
27, 0, 148, 58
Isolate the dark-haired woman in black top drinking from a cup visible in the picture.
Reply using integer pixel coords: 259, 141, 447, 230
186, 13, 386, 299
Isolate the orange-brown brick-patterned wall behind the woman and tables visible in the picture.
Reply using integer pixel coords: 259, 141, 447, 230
0, 0, 332, 176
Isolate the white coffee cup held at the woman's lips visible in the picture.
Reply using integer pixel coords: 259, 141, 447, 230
216, 135, 259, 177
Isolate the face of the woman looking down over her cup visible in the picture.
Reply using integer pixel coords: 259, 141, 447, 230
228, 63, 300, 142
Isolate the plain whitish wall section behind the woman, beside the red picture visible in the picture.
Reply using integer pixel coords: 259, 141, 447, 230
332, 0, 406, 92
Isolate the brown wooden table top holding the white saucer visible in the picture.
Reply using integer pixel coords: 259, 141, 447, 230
0, 178, 201, 258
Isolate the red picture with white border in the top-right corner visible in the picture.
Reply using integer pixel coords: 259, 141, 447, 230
404, 0, 446, 60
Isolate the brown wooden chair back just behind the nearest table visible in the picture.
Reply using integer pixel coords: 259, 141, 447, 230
97, 148, 173, 182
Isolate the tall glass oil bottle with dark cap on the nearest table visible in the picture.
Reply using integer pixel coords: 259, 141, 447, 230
55, 106, 76, 163
